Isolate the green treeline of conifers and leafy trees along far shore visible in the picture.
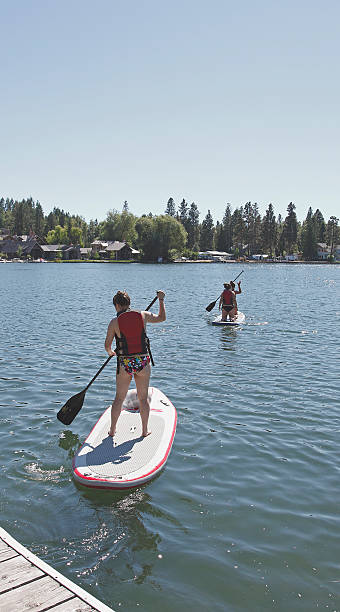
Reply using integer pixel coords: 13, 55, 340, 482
0, 198, 340, 260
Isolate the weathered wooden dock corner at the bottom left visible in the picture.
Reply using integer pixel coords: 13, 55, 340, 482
0, 527, 113, 612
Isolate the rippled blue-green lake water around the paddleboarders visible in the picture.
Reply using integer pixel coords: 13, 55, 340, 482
0, 263, 340, 612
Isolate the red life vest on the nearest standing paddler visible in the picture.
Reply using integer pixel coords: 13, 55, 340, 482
116, 310, 148, 355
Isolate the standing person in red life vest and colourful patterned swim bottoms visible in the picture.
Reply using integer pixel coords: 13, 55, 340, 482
105, 290, 166, 437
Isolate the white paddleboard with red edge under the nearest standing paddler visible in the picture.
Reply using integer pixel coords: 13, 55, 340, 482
73, 387, 177, 489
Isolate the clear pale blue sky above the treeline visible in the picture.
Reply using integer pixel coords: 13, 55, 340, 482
0, 0, 340, 221
